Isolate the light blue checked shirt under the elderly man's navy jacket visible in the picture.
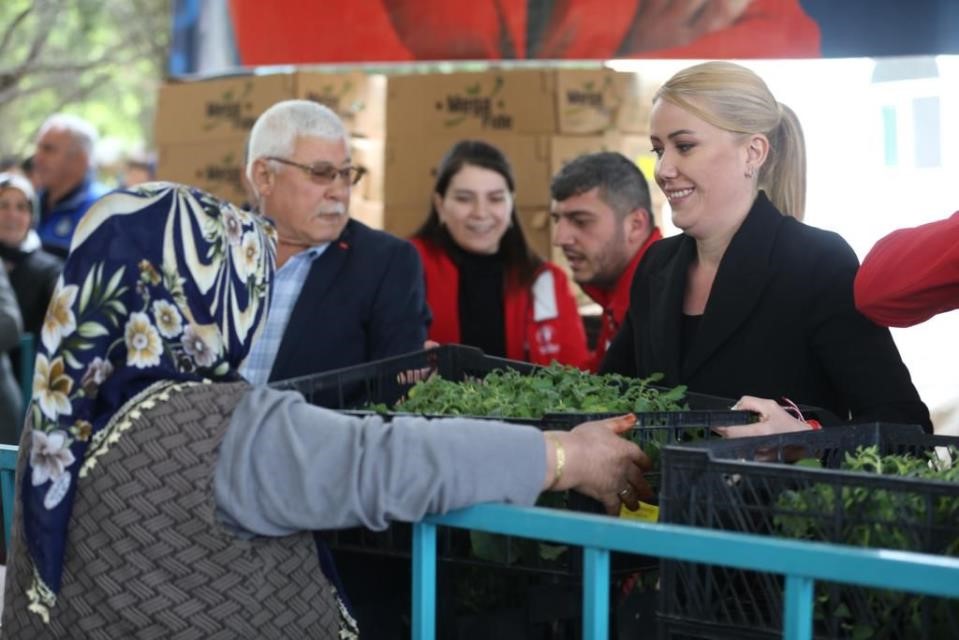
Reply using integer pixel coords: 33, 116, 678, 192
240, 242, 330, 384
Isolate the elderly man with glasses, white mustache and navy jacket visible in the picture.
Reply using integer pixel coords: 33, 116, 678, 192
240, 100, 430, 639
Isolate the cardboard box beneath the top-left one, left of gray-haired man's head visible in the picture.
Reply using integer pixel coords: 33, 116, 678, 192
157, 135, 248, 206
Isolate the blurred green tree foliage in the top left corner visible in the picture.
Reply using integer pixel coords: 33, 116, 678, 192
0, 0, 172, 155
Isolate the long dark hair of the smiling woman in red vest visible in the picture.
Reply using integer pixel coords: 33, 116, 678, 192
413, 140, 543, 284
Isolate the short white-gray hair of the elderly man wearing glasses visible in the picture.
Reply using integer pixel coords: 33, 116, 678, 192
246, 100, 349, 183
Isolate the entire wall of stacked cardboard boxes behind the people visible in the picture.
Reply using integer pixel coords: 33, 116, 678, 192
155, 68, 658, 252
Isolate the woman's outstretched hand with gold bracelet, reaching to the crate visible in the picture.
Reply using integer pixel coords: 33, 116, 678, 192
546, 414, 653, 514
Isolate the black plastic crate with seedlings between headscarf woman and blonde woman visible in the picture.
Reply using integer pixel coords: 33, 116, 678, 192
271, 345, 753, 576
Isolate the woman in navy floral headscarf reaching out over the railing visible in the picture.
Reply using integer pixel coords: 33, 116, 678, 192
3, 183, 644, 638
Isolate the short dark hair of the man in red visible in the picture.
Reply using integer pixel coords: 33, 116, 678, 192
549, 151, 656, 226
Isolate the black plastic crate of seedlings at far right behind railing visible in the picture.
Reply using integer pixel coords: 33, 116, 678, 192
658, 424, 959, 640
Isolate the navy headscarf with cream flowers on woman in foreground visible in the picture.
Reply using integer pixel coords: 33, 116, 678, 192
22, 183, 275, 618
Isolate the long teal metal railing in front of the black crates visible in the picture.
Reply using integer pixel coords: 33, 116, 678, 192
413, 504, 959, 640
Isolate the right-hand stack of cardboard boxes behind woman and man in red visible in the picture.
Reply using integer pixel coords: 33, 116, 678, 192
382, 69, 664, 258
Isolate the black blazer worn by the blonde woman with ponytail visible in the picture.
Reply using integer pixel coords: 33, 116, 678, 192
601, 192, 932, 430
